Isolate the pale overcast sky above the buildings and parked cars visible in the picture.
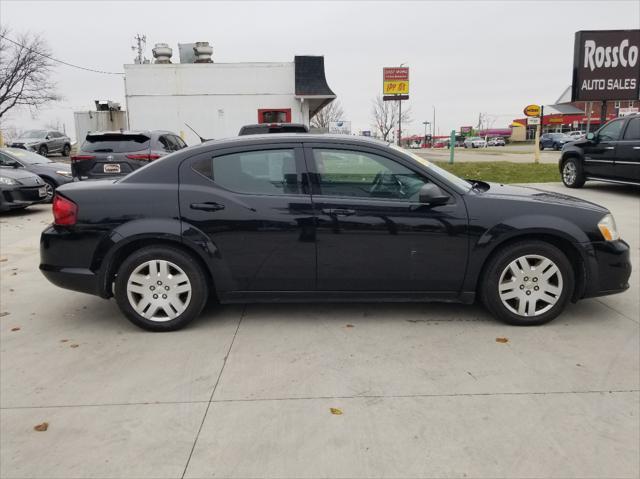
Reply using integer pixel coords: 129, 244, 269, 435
0, 0, 640, 141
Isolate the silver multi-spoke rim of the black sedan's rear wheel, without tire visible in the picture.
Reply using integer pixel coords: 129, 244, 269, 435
127, 260, 192, 322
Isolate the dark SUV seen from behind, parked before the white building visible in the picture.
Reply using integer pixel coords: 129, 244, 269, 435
71, 130, 187, 180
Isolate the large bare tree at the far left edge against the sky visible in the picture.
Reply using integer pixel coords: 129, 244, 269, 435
0, 28, 60, 118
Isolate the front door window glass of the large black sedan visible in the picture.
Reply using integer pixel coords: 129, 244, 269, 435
313, 148, 427, 201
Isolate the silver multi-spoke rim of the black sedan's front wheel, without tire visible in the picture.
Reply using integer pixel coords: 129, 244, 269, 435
498, 255, 563, 317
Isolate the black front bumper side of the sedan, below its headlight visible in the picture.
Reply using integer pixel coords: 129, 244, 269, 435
583, 240, 631, 298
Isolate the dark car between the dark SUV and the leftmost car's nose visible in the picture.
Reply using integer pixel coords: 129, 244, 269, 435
0, 148, 73, 202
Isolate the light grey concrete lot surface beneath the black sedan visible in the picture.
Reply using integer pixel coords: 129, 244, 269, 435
0, 183, 640, 478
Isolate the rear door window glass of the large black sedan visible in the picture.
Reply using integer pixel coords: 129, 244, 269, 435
193, 149, 302, 195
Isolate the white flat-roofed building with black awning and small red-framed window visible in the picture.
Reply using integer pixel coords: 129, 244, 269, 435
124, 46, 335, 145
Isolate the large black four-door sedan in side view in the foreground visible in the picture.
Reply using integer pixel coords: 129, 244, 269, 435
40, 134, 631, 331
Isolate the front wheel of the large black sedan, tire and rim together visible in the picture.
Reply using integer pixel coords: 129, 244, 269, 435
480, 240, 575, 326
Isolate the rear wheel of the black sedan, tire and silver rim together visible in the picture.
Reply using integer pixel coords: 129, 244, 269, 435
115, 246, 209, 332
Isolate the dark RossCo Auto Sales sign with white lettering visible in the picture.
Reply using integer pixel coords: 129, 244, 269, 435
571, 30, 640, 101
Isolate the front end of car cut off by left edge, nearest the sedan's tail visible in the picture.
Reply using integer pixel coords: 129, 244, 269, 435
0, 165, 47, 211
